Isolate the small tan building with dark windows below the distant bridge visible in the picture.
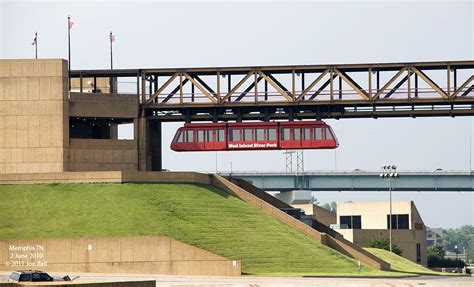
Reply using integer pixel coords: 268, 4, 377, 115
335, 201, 427, 266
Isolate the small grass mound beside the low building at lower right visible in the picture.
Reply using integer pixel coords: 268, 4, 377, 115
364, 248, 459, 275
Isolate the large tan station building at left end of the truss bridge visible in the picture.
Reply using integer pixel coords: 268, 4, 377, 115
0, 59, 161, 174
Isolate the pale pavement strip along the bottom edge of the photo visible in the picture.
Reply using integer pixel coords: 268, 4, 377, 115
0, 272, 474, 287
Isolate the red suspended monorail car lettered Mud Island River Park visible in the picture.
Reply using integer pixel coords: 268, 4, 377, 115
171, 121, 339, 151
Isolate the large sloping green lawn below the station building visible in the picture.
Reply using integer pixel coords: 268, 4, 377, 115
0, 184, 406, 276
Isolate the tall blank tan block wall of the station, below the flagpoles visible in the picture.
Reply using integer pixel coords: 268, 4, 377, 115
0, 60, 69, 174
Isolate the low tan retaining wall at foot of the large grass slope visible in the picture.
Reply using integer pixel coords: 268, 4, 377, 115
0, 236, 241, 276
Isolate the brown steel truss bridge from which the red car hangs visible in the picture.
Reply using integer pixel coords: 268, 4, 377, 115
70, 61, 474, 122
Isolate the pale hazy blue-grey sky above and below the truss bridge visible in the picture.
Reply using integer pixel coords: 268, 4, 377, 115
0, 0, 474, 230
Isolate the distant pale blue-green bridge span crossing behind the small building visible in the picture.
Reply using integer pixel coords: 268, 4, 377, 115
226, 170, 474, 192
